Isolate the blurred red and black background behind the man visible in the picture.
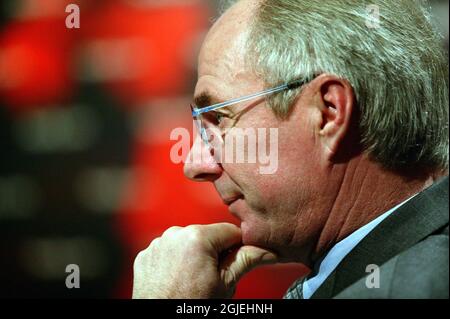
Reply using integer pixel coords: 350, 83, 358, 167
0, 0, 316, 298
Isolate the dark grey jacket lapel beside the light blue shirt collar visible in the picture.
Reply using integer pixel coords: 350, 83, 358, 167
312, 177, 448, 298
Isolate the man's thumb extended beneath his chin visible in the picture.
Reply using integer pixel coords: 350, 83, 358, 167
220, 246, 277, 287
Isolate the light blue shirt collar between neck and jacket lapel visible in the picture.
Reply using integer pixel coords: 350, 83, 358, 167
303, 195, 416, 299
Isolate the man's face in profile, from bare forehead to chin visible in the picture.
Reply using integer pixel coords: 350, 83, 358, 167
185, 1, 325, 262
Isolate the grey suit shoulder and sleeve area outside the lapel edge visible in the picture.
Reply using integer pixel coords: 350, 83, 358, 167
336, 225, 449, 299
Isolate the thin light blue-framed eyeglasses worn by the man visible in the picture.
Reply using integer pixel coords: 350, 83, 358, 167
190, 80, 307, 149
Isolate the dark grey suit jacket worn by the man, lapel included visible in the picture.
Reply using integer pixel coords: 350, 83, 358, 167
286, 177, 449, 299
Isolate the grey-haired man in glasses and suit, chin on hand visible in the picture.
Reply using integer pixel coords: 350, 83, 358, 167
133, 0, 448, 298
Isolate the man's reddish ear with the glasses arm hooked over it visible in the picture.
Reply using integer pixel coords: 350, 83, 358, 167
318, 75, 355, 158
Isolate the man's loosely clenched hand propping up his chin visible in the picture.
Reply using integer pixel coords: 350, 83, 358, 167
133, 223, 277, 299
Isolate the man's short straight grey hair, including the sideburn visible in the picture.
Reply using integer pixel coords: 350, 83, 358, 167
223, 0, 449, 174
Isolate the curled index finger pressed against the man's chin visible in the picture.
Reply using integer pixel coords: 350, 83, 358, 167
200, 223, 242, 253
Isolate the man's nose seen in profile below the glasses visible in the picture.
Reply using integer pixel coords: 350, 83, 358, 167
184, 136, 222, 182
